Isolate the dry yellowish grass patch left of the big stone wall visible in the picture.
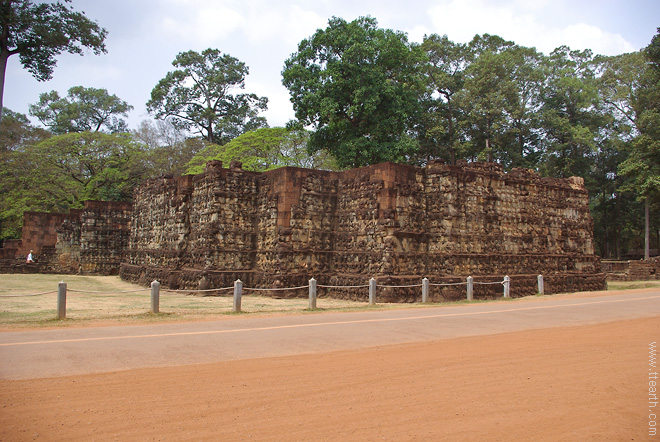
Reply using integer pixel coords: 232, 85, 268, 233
0, 274, 367, 328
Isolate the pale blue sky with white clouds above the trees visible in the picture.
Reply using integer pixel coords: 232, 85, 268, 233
4, 0, 660, 129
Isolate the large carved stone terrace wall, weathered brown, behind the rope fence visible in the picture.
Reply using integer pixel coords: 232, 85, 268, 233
121, 161, 604, 300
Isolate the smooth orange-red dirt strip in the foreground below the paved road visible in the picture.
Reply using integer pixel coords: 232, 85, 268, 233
0, 316, 660, 442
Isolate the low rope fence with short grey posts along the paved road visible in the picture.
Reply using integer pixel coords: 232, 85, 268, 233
0, 275, 544, 319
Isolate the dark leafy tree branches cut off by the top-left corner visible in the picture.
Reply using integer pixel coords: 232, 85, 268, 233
0, 0, 107, 119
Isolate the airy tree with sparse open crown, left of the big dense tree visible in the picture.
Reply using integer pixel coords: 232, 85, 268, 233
147, 49, 268, 144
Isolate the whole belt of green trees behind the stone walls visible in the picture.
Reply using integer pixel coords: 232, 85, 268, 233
0, 12, 660, 258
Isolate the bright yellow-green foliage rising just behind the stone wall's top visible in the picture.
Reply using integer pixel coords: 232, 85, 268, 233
187, 127, 336, 174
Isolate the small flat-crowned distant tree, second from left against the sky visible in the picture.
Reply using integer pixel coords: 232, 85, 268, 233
30, 86, 133, 135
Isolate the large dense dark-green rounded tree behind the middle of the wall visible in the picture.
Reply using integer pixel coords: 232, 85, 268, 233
282, 17, 424, 167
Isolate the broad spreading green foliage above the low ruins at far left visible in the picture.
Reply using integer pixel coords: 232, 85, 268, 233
0, 132, 145, 238
